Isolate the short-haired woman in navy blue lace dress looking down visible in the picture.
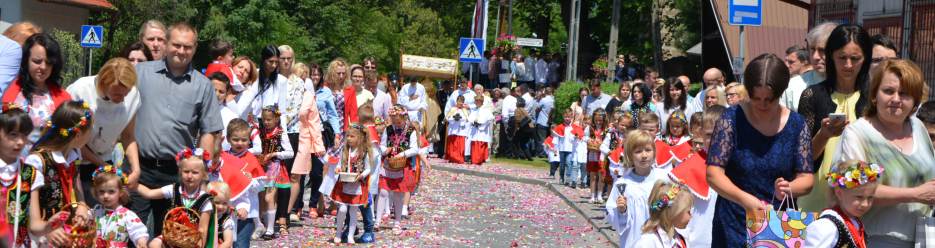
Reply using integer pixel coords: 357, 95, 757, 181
707, 54, 814, 247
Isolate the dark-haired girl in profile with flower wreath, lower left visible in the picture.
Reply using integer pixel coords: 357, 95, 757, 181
25, 101, 92, 246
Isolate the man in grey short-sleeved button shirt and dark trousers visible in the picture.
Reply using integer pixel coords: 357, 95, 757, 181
130, 23, 224, 237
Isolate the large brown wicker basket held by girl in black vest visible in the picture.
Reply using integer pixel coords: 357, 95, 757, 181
162, 208, 201, 248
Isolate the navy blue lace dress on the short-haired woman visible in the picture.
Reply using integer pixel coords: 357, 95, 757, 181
707, 106, 812, 247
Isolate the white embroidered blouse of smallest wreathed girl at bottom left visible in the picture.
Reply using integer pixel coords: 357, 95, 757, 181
92, 205, 149, 248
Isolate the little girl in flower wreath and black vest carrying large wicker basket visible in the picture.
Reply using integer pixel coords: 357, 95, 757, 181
136, 148, 214, 248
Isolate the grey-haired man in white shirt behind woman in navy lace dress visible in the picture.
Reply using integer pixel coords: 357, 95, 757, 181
779, 22, 838, 111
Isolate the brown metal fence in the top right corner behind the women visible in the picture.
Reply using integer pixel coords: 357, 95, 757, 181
809, 0, 935, 100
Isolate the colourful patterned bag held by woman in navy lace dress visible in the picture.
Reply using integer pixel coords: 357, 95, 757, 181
746, 192, 818, 247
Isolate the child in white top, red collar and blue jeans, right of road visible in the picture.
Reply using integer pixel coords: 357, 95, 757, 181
552, 111, 584, 187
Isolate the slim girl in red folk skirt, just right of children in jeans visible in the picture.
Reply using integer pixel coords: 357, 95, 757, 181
584, 108, 607, 203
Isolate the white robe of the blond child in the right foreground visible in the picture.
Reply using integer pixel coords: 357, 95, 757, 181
605, 168, 668, 248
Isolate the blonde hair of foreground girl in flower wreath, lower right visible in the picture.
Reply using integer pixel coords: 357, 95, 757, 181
643, 181, 694, 238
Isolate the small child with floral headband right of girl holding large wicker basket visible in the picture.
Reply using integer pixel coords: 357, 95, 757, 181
208, 182, 234, 248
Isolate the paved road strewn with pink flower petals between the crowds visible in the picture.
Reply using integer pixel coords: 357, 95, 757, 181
253, 161, 612, 247
